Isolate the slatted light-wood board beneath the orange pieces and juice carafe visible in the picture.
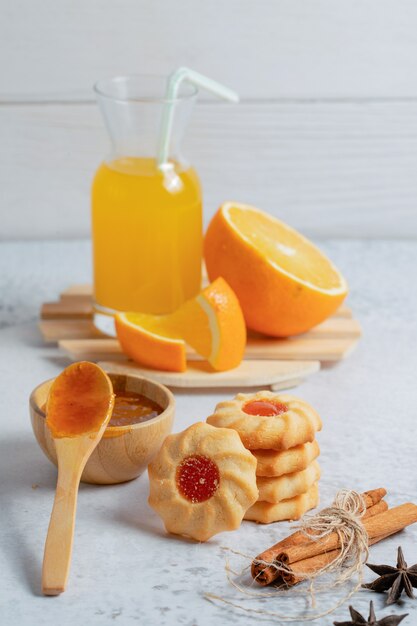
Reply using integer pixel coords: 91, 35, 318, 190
39, 285, 361, 389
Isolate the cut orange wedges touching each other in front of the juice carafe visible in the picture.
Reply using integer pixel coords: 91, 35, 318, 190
115, 278, 246, 372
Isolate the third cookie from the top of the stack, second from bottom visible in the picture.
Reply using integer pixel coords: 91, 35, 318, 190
256, 461, 320, 504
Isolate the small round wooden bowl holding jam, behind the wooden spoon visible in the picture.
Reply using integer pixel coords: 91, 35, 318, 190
29, 373, 175, 485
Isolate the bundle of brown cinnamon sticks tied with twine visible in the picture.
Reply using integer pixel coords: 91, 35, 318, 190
251, 488, 417, 586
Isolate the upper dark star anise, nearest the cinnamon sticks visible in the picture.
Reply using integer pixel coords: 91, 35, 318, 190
362, 546, 417, 604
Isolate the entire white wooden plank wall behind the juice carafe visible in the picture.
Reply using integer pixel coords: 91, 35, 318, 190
0, 0, 417, 239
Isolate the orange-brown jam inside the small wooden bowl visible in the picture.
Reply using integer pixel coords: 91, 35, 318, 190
109, 391, 164, 426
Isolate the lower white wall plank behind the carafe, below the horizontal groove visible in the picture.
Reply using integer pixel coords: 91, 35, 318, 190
0, 103, 417, 238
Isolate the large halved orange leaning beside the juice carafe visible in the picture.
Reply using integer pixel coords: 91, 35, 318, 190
204, 202, 348, 337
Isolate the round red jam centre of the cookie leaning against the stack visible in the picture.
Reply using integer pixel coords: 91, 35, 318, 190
176, 455, 220, 503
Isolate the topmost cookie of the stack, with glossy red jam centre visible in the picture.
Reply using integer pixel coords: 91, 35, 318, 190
207, 391, 321, 451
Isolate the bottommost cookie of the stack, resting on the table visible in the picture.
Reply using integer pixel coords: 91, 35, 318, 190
244, 483, 319, 524
